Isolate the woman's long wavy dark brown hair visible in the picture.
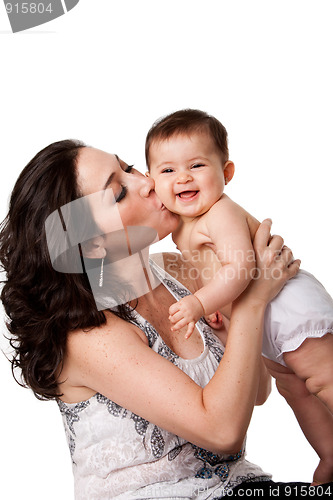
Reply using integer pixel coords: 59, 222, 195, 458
0, 140, 128, 399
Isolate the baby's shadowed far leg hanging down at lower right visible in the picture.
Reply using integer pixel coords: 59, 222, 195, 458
265, 360, 333, 484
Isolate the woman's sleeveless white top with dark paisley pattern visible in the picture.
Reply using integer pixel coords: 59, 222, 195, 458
58, 261, 270, 500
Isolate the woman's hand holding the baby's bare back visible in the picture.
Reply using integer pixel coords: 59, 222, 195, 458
241, 219, 301, 304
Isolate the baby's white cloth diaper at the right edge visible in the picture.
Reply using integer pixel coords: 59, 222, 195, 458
262, 270, 333, 366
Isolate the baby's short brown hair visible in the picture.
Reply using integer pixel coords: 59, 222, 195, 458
145, 109, 229, 170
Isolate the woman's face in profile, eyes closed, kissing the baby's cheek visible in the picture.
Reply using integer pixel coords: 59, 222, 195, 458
77, 147, 178, 250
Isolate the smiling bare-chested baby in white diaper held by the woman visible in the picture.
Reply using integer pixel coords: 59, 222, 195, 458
146, 109, 333, 484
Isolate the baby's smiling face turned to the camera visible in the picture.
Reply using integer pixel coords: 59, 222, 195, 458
149, 132, 224, 218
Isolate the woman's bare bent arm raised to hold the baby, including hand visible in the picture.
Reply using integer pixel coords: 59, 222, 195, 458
64, 223, 299, 453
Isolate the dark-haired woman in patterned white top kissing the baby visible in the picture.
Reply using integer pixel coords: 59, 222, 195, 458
0, 141, 312, 500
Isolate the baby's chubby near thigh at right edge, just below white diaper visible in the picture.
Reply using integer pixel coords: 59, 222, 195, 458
283, 333, 333, 413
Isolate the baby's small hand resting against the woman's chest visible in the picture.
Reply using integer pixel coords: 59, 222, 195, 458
169, 295, 204, 339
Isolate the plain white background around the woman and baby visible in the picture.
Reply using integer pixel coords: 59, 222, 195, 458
0, 0, 333, 500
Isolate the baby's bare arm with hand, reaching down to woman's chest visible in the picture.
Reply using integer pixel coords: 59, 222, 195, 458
170, 200, 255, 337
